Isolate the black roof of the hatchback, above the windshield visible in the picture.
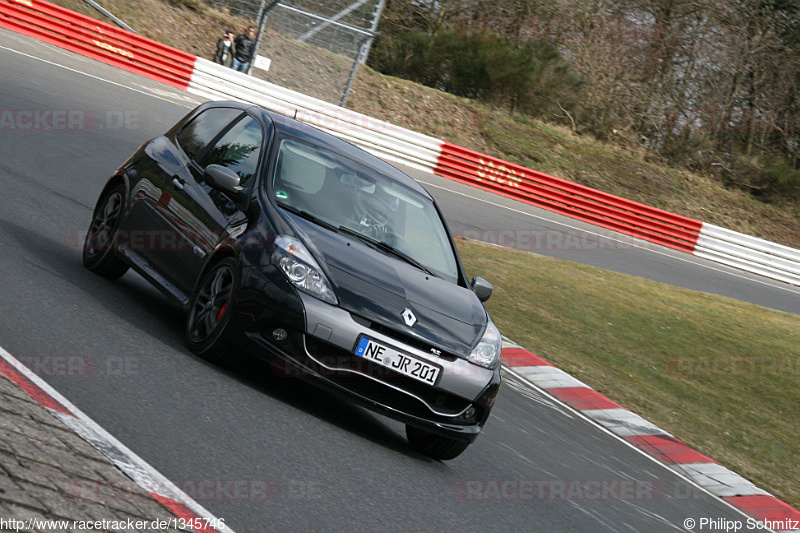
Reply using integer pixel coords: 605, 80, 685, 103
204, 101, 432, 199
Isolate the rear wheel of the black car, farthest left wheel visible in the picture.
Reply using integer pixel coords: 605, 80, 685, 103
83, 184, 128, 280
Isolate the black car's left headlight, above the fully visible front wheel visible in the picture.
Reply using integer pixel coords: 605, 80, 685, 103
272, 235, 339, 305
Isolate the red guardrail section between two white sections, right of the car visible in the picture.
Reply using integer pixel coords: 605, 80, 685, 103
435, 143, 702, 252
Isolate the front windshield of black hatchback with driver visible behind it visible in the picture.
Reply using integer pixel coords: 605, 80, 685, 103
271, 138, 458, 282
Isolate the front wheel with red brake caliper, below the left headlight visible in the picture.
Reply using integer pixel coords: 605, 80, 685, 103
186, 257, 238, 363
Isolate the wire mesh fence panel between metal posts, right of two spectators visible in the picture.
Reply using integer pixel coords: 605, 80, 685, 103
209, 0, 382, 104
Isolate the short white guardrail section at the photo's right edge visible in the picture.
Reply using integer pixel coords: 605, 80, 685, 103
694, 224, 800, 285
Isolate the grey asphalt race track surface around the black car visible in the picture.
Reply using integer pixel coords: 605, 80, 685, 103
0, 30, 788, 533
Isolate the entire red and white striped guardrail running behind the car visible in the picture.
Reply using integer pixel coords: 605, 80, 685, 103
0, 0, 800, 285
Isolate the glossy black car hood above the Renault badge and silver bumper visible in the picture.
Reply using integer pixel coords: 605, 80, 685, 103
289, 214, 487, 357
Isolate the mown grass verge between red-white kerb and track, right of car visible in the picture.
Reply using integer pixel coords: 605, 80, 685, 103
459, 237, 800, 507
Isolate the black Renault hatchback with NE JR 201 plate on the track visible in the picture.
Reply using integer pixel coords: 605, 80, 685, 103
83, 102, 501, 459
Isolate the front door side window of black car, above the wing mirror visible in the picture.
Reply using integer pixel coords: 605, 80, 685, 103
199, 116, 264, 187
